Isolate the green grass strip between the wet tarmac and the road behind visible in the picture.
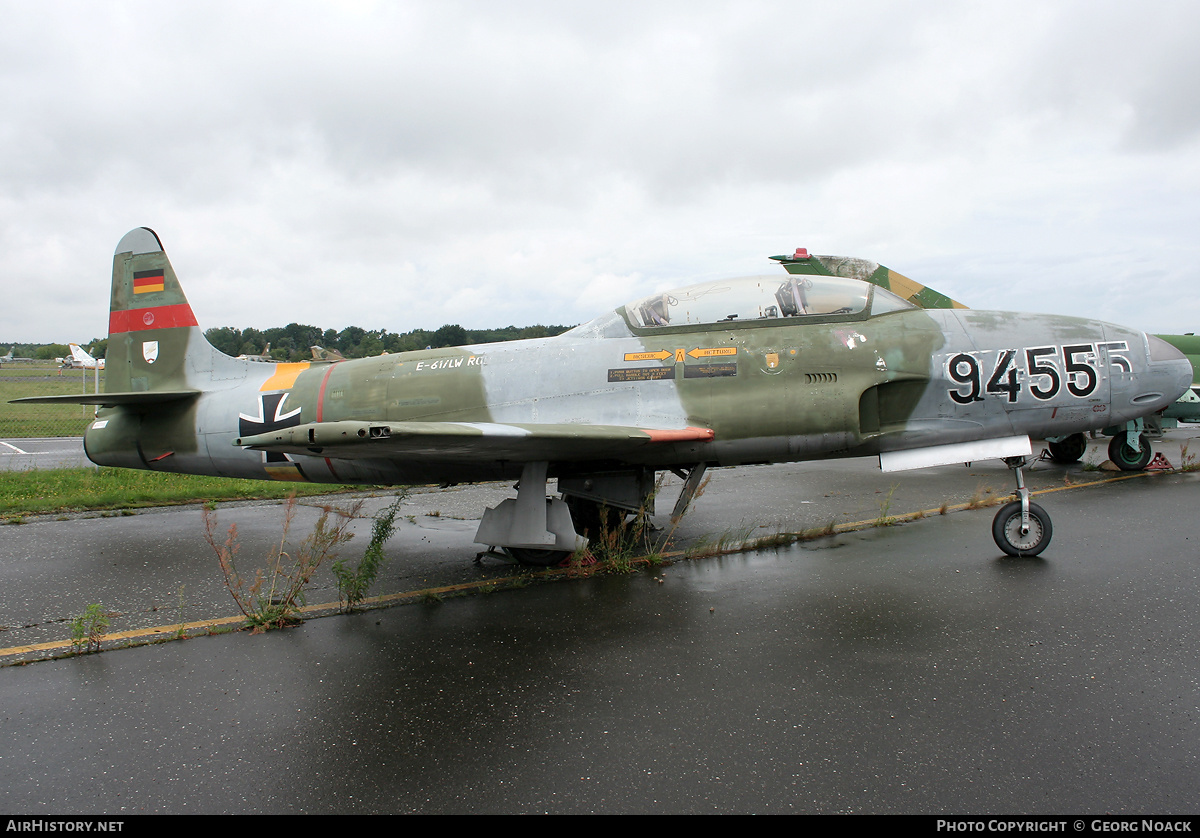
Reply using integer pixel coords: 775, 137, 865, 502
0, 468, 372, 520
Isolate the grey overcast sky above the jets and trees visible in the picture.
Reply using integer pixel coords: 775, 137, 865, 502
0, 0, 1200, 342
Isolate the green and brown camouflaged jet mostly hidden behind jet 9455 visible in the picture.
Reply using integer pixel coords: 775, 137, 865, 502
770, 247, 1200, 472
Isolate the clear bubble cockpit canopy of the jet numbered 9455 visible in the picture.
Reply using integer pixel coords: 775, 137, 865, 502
625, 275, 916, 328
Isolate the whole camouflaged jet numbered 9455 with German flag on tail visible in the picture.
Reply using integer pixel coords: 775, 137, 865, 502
18, 227, 1192, 564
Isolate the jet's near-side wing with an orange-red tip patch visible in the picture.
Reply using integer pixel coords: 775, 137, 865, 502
234, 420, 713, 462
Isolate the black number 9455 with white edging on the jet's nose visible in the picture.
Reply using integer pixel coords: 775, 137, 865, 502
946, 341, 1133, 405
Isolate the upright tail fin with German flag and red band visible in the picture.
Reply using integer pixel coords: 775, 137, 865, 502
104, 227, 204, 393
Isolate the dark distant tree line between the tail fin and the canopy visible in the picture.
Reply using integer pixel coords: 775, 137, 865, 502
204, 323, 571, 361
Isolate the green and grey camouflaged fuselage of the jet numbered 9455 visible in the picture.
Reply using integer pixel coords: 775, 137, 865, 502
86, 298, 1190, 483
